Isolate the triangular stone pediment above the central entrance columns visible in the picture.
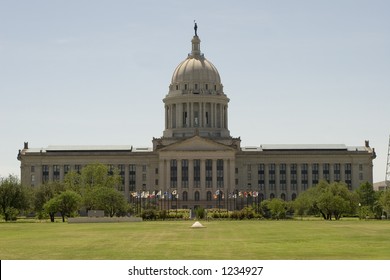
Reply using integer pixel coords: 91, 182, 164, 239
161, 135, 234, 152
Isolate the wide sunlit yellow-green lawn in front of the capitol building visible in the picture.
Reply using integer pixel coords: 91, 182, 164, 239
0, 220, 390, 260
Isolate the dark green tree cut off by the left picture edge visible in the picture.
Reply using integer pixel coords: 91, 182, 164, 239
0, 175, 31, 221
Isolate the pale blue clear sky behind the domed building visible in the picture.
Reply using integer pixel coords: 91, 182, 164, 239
0, 0, 390, 182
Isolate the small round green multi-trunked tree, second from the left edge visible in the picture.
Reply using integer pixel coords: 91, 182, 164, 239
44, 190, 82, 222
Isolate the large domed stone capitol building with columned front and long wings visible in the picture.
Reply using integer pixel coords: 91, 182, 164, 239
18, 26, 375, 209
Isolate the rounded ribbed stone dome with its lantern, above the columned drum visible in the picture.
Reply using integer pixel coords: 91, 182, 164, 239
171, 35, 221, 88
